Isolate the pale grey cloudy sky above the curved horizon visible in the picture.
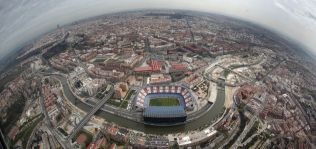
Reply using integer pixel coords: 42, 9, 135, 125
0, 0, 316, 59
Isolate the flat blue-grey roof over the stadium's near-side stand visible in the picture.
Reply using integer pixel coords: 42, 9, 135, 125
143, 106, 186, 118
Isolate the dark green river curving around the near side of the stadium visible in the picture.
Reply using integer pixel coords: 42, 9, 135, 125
54, 75, 225, 134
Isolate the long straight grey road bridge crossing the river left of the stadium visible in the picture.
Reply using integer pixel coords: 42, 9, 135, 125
67, 89, 114, 140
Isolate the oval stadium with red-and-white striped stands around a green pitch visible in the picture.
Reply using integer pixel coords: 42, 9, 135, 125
135, 86, 194, 125
